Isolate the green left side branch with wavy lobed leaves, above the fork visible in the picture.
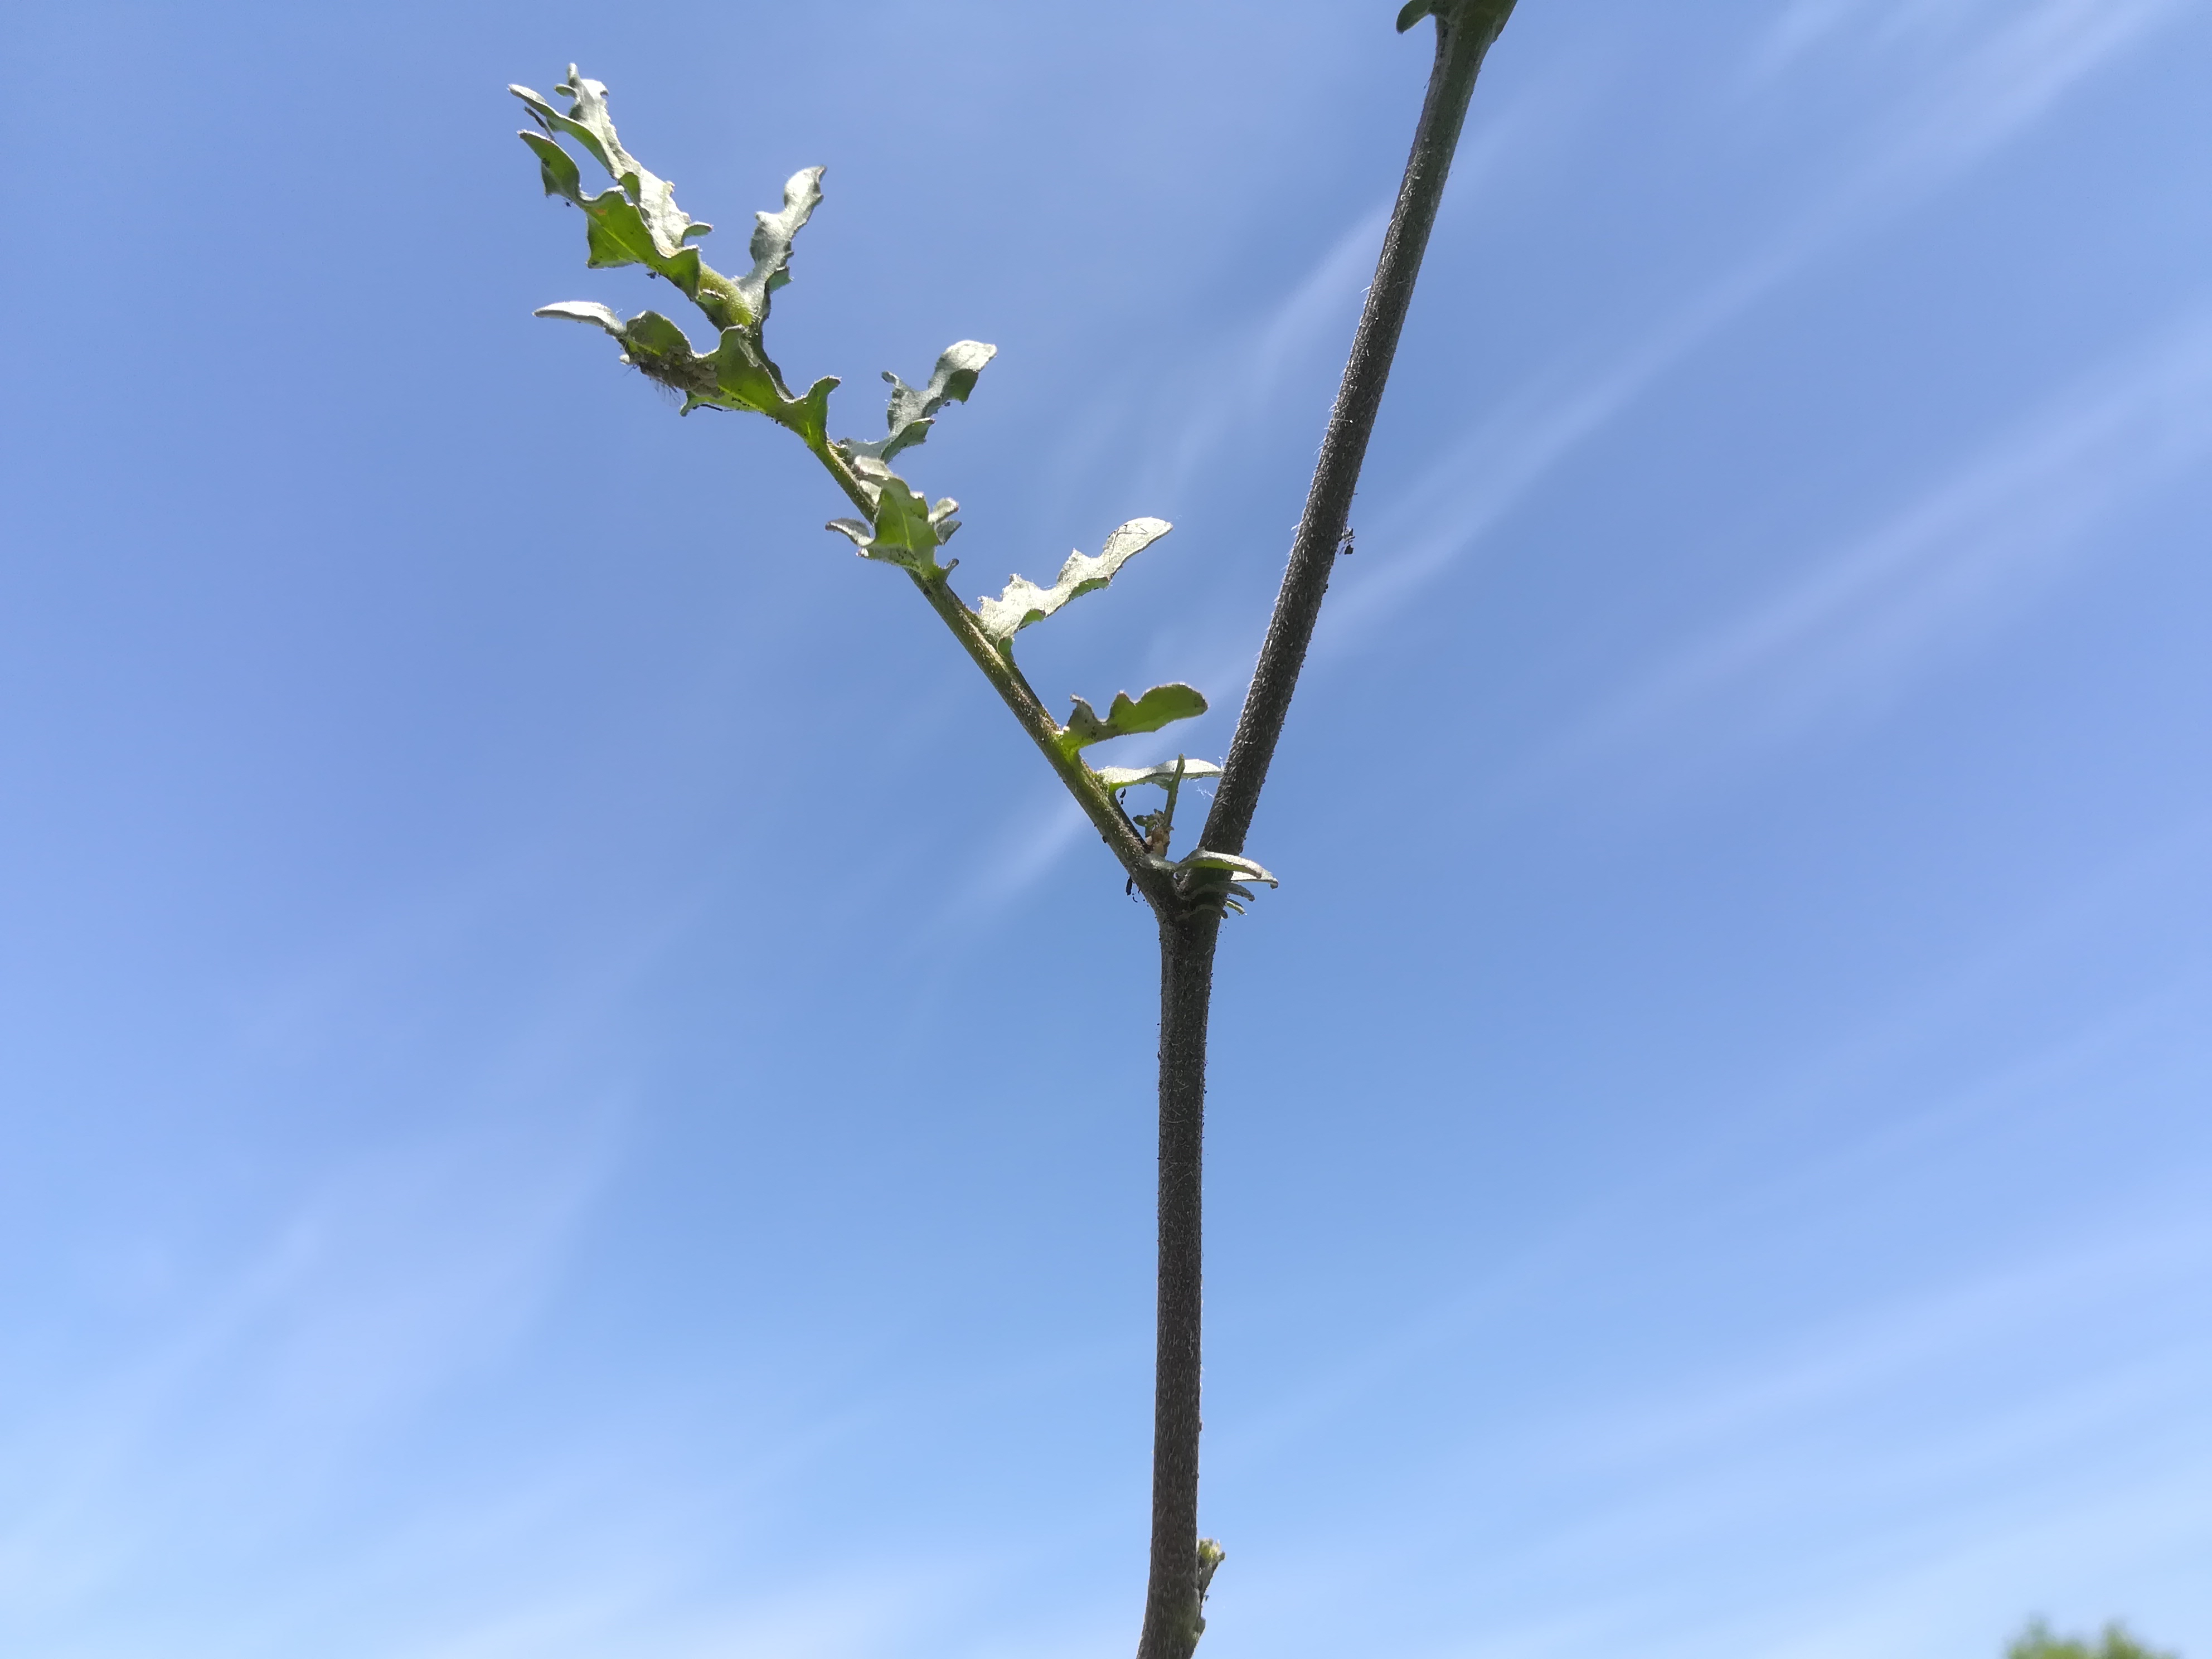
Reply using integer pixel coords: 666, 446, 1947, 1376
507, 64, 1274, 909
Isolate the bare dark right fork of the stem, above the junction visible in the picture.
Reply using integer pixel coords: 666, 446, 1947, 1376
1204, 0, 1513, 871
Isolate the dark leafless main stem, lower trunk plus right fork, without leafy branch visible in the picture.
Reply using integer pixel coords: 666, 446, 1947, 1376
1137, 0, 1513, 1659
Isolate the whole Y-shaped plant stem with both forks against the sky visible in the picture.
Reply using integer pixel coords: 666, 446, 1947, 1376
516, 0, 1515, 1659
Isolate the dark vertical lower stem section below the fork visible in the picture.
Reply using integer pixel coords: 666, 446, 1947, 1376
1137, 905, 1221, 1659
